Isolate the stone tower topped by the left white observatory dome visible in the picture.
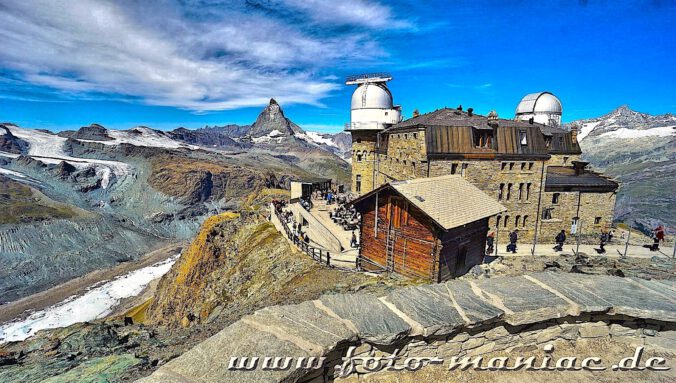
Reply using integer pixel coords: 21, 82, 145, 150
345, 73, 401, 195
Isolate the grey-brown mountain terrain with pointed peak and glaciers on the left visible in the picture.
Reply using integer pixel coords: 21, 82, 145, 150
0, 100, 349, 303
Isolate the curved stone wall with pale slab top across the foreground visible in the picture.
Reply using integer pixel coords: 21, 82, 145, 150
136, 272, 676, 383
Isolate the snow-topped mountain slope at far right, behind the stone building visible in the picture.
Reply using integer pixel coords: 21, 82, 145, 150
568, 106, 676, 236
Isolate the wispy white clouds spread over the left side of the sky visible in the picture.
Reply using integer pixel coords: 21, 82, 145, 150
0, 0, 410, 111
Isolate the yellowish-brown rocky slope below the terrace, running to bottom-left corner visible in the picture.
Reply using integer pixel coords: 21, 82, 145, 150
0, 200, 410, 383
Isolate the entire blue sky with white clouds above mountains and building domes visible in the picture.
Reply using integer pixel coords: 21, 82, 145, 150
0, 0, 676, 132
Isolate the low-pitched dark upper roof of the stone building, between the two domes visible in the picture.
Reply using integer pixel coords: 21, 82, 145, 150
388, 108, 567, 136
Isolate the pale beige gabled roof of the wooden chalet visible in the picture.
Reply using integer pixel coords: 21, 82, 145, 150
353, 175, 507, 230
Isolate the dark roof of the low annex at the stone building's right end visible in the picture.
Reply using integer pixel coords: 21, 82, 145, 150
545, 166, 619, 192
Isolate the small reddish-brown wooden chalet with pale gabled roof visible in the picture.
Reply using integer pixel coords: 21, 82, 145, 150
353, 175, 506, 282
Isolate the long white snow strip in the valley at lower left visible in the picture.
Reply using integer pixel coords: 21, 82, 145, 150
0, 254, 180, 344
